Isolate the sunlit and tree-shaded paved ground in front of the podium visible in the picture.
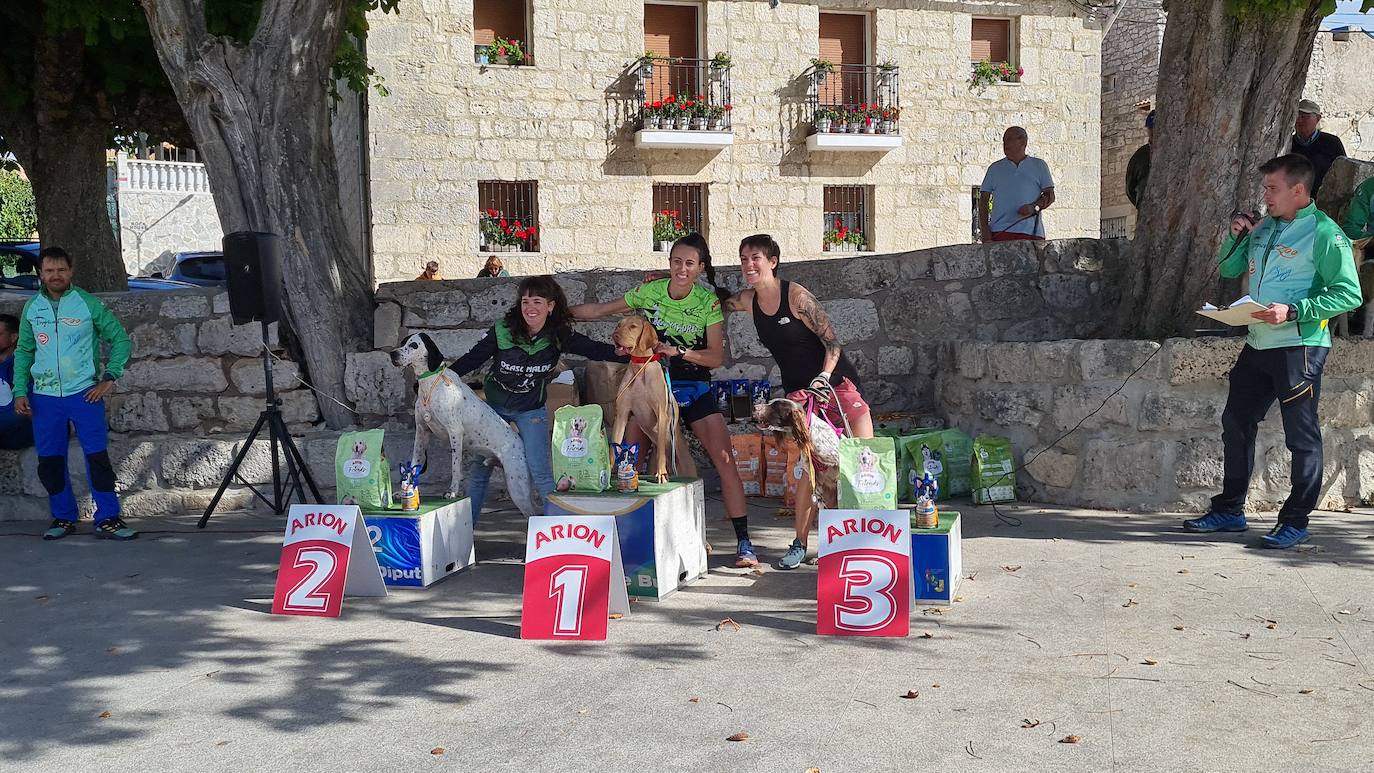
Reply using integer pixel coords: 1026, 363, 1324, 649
0, 501, 1374, 773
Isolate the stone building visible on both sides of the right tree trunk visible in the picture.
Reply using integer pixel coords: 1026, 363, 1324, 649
1101, 0, 1374, 238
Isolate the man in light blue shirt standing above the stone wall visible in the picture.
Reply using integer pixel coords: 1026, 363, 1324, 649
978, 126, 1054, 242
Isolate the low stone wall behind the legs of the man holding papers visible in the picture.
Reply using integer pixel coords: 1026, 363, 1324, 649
936, 338, 1374, 511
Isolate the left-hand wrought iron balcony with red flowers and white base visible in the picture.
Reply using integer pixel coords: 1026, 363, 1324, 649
633, 54, 734, 148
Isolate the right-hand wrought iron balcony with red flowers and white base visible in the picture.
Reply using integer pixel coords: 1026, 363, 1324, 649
805, 62, 901, 151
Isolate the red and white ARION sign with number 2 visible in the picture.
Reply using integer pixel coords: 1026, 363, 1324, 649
272, 505, 386, 618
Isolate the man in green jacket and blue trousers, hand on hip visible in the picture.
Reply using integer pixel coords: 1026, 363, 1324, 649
14, 247, 139, 540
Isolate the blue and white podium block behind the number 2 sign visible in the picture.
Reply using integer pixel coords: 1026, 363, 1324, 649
363, 497, 477, 588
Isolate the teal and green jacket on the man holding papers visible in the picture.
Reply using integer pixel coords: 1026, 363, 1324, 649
1219, 203, 1360, 349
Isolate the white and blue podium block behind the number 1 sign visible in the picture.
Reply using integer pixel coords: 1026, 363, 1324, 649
544, 478, 706, 600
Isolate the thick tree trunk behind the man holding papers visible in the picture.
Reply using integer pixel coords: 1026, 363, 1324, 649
1110, 0, 1322, 338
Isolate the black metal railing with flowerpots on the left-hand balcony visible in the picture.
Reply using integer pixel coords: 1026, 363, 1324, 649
633, 56, 732, 132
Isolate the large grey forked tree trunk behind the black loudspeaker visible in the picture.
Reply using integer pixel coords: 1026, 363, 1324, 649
143, 0, 372, 428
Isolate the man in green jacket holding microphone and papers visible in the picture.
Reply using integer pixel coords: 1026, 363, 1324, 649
1183, 154, 1360, 548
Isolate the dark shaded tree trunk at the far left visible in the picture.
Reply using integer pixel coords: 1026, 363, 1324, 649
0, 26, 128, 292
